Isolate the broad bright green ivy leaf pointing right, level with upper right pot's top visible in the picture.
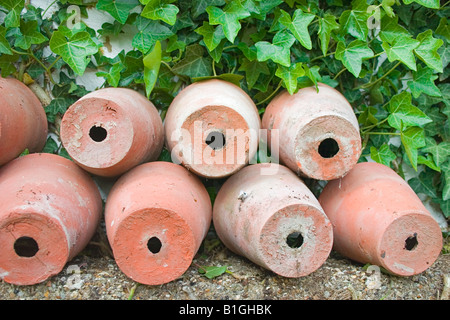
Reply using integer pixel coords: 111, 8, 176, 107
388, 91, 432, 130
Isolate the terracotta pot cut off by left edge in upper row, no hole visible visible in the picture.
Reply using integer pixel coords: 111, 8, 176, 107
0, 77, 48, 166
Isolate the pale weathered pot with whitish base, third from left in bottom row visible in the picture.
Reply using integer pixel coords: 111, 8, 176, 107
213, 164, 333, 277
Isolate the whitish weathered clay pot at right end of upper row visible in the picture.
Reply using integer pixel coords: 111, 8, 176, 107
262, 84, 361, 180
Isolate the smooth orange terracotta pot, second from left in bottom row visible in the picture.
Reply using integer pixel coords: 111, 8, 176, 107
105, 161, 212, 285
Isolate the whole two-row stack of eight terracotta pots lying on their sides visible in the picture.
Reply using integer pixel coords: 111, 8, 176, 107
0, 78, 442, 285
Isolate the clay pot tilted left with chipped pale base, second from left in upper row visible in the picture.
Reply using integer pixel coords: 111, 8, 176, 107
61, 88, 164, 177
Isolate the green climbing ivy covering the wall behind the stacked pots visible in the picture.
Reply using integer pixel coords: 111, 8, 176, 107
0, 0, 450, 221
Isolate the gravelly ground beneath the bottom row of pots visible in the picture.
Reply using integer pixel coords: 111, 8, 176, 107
0, 225, 450, 301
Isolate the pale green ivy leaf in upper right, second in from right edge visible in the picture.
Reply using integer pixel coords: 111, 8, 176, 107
382, 37, 420, 71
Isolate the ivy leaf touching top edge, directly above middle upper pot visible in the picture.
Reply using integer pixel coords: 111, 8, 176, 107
206, 0, 250, 43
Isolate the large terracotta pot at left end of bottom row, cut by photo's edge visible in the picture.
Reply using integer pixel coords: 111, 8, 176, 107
0, 153, 102, 285
